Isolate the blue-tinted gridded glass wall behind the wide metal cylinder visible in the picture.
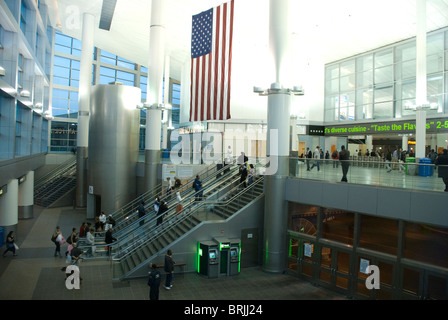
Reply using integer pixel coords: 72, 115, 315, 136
50, 33, 181, 152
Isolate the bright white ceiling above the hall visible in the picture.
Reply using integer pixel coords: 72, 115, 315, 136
47, 0, 448, 80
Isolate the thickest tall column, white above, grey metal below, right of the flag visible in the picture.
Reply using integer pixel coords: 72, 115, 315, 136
263, 0, 291, 273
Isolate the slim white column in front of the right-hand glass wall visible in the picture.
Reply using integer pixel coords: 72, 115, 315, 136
415, 0, 428, 159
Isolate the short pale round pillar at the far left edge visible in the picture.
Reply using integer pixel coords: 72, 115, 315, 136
0, 179, 19, 243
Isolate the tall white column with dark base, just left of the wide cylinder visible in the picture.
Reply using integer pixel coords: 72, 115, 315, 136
76, 13, 95, 207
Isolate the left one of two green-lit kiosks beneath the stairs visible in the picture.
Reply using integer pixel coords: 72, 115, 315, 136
198, 241, 219, 278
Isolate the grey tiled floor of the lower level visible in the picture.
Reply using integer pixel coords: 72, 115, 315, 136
0, 206, 346, 300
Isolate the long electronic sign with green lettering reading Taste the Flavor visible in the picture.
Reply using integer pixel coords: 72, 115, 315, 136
325, 118, 448, 136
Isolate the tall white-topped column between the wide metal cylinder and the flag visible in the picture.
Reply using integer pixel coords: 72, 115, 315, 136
145, 0, 165, 190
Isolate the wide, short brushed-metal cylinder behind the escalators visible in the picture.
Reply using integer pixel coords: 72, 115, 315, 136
88, 85, 141, 213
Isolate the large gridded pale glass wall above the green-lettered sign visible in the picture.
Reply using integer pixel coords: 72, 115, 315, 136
324, 29, 448, 123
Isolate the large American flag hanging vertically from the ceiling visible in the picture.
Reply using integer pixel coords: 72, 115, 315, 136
190, 0, 234, 121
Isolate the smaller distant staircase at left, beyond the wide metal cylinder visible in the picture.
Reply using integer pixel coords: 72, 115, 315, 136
34, 158, 76, 207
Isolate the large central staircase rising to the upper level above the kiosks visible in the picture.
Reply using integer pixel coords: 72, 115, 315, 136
113, 175, 264, 280
